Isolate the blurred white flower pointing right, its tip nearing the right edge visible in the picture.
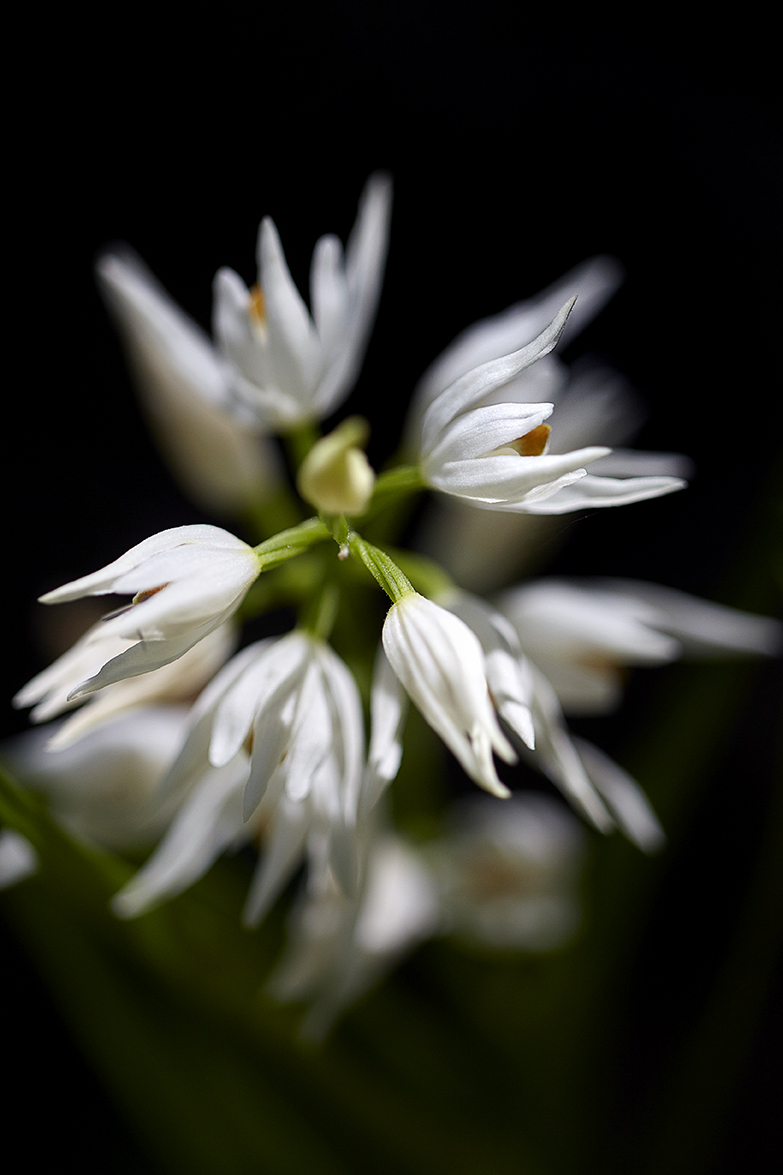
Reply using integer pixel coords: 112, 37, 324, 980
500, 579, 783, 714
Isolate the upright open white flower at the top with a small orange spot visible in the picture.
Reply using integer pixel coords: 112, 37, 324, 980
214, 175, 392, 431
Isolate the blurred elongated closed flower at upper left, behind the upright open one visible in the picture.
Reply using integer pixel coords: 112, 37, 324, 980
96, 250, 281, 513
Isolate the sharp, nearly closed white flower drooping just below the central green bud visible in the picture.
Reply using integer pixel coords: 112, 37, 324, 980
383, 592, 516, 797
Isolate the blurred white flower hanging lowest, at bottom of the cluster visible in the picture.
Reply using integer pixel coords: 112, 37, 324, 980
270, 832, 441, 1038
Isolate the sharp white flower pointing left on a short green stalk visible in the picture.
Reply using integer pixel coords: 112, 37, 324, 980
36, 525, 261, 700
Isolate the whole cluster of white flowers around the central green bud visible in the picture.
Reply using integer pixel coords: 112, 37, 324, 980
9, 175, 781, 1030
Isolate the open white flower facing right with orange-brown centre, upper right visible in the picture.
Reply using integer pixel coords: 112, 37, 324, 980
419, 298, 684, 513
